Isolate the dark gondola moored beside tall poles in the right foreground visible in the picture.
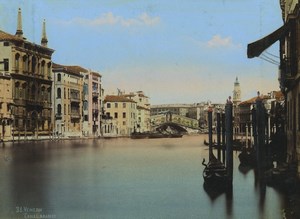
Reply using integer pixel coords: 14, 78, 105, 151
202, 155, 227, 185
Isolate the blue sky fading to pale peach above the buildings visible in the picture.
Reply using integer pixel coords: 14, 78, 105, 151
0, 0, 283, 104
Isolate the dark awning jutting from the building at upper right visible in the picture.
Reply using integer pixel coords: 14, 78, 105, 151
247, 22, 290, 58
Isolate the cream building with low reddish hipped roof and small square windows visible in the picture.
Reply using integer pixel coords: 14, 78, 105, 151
104, 94, 137, 136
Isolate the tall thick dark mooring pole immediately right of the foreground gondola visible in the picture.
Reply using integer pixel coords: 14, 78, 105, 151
225, 97, 233, 185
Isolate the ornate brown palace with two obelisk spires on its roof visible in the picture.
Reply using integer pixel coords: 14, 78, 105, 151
0, 9, 54, 140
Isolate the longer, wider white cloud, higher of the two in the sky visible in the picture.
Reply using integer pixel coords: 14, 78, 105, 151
61, 12, 160, 27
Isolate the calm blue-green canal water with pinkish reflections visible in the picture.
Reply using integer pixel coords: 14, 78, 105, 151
0, 135, 286, 219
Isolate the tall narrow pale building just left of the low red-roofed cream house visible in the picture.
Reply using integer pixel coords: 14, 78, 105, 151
82, 70, 103, 137
